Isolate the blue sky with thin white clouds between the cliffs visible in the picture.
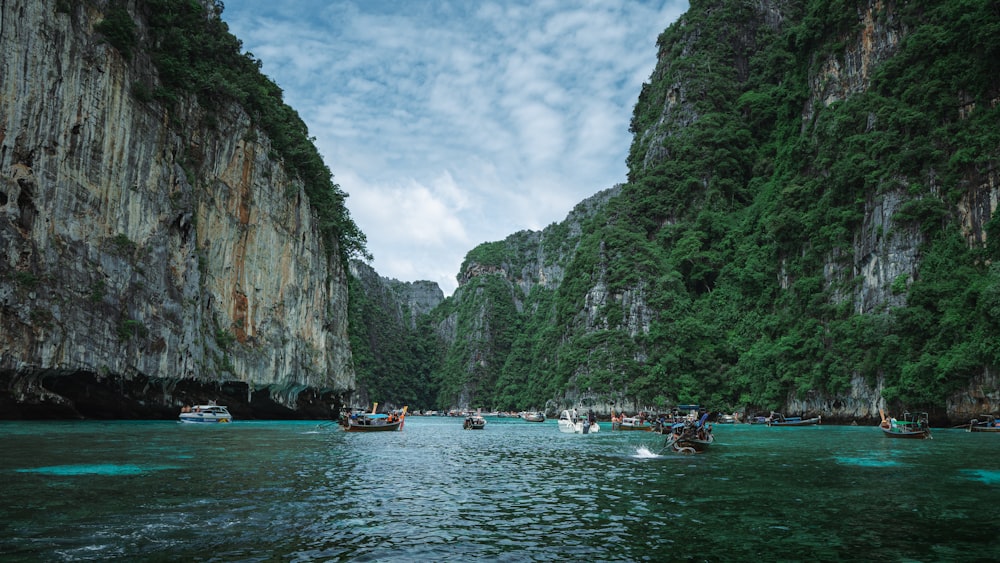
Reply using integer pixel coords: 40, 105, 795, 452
222, 0, 688, 295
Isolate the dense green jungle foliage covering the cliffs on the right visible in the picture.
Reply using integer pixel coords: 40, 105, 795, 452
420, 0, 1000, 410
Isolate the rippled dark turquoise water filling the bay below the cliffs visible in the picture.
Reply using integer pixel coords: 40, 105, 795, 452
0, 417, 1000, 562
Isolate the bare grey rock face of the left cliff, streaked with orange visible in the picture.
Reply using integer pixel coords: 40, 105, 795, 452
0, 0, 354, 416
